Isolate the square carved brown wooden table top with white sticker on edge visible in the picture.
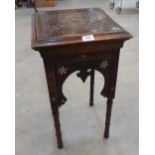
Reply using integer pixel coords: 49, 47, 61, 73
31, 8, 132, 49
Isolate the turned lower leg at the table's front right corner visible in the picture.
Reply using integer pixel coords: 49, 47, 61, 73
104, 98, 113, 139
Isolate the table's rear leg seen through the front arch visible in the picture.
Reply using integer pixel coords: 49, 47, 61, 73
90, 69, 95, 106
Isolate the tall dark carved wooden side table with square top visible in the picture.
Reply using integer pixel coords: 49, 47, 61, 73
31, 8, 132, 148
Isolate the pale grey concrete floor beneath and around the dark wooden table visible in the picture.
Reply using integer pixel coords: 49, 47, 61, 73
15, 0, 139, 155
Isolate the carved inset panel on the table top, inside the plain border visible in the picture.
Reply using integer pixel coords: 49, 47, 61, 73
36, 8, 124, 41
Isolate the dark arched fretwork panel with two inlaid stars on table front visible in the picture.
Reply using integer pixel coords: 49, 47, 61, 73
55, 55, 117, 106
